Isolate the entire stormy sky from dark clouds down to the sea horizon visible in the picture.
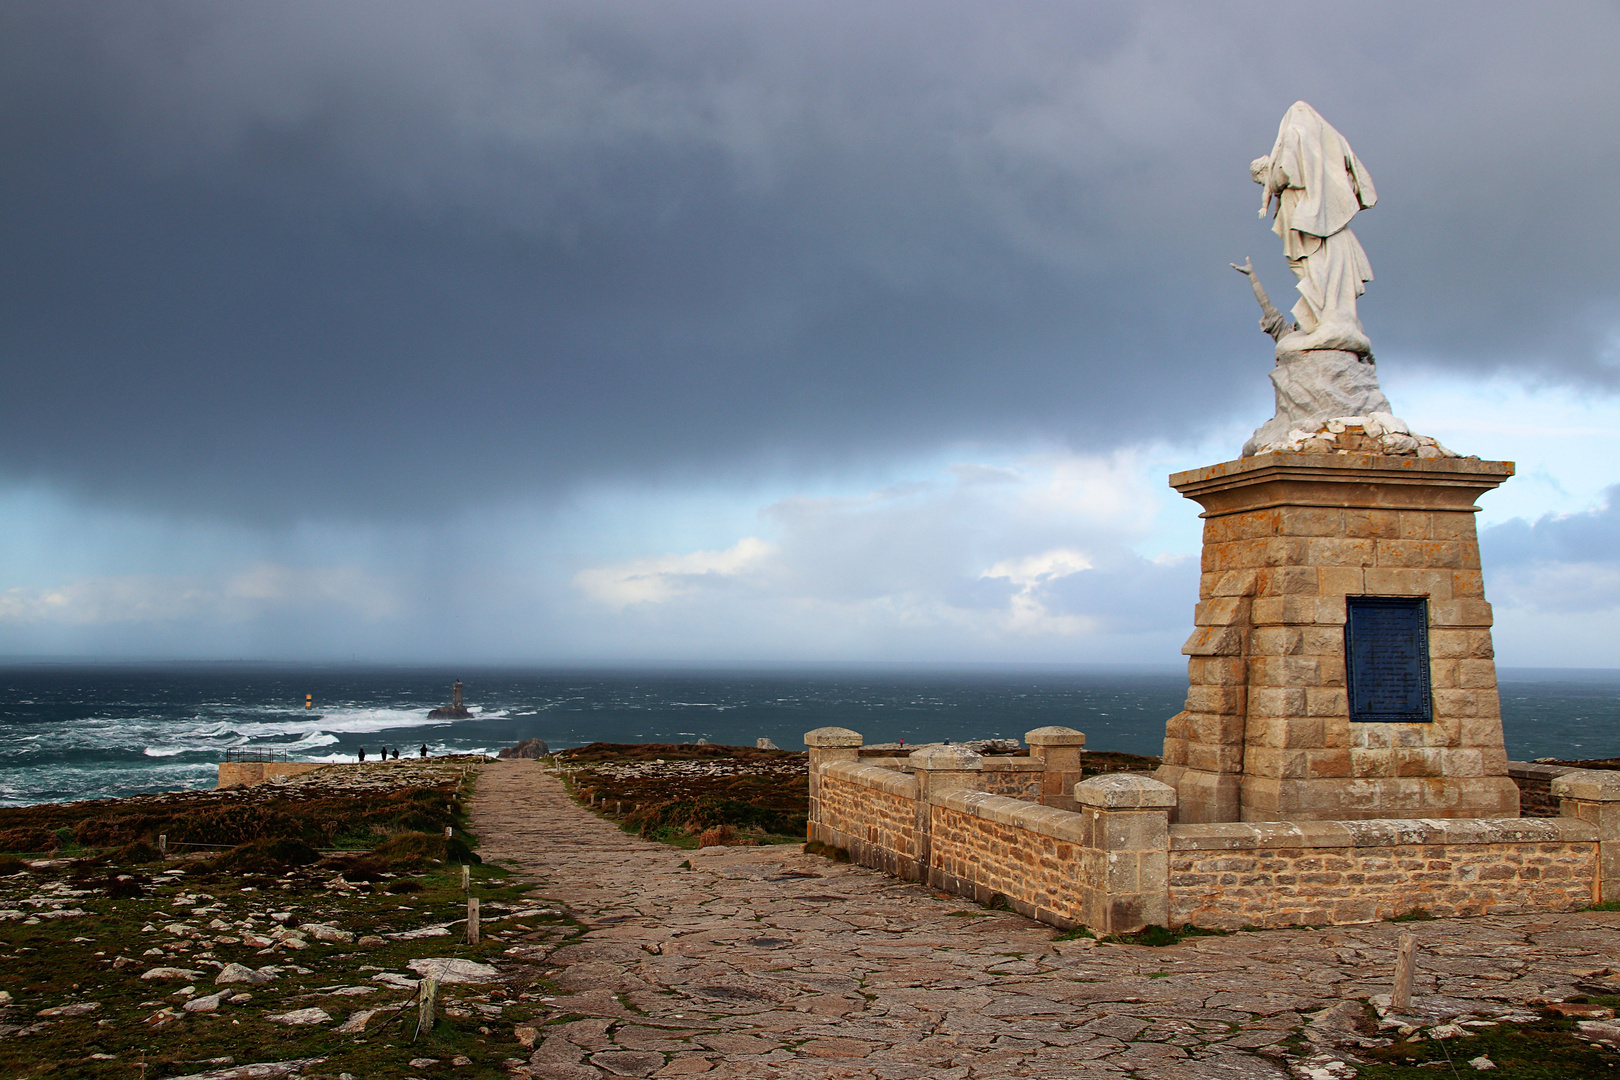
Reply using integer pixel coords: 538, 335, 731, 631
0, 0, 1620, 667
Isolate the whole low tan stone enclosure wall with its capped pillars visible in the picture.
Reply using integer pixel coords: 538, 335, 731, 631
805, 729, 1620, 934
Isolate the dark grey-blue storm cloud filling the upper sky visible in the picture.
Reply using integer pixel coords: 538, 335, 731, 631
0, 3, 1620, 518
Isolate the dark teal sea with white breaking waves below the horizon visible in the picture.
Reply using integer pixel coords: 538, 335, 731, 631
0, 664, 1620, 806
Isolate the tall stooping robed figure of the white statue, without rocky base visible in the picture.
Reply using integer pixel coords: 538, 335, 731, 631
1265, 102, 1379, 342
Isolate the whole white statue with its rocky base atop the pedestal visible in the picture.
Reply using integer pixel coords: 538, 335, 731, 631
1231, 102, 1450, 457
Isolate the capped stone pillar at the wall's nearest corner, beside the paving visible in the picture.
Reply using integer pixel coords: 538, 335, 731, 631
1074, 772, 1176, 934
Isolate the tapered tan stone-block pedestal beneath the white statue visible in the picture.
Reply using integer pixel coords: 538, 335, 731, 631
1157, 453, 1518, 823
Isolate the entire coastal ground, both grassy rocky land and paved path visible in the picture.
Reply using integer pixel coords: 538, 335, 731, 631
0, 745, 1620, 1080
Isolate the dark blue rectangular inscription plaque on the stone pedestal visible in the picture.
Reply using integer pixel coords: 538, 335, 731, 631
1345, 596, 1434, 724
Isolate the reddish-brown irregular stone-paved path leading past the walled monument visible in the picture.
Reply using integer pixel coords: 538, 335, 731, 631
473, 763, 1620, 1080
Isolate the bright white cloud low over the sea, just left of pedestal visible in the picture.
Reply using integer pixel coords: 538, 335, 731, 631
573, 452, 1191, 659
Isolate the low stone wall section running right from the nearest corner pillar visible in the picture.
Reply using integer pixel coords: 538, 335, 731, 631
1168, 818, 1599, 929
